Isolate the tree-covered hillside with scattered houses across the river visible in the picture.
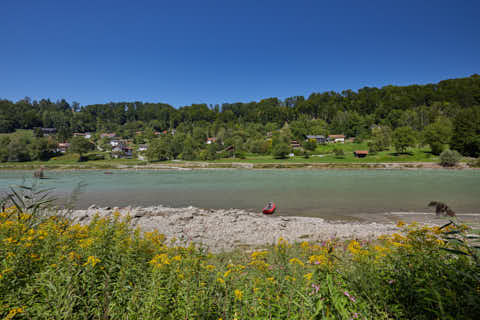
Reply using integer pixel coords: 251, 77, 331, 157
0, 75, 480, 166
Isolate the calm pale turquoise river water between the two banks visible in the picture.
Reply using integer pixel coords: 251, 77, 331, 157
0, 169, 480, 217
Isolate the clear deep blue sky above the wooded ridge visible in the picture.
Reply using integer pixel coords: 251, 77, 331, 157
0, 0, 480, 107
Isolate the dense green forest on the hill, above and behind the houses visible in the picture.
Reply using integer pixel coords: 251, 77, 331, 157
0, 74, 480, 158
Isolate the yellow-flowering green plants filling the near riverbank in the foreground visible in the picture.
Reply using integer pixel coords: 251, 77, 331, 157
0, 208, 480, 320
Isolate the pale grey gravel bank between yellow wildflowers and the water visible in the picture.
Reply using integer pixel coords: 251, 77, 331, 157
65, 205, 398, 252
